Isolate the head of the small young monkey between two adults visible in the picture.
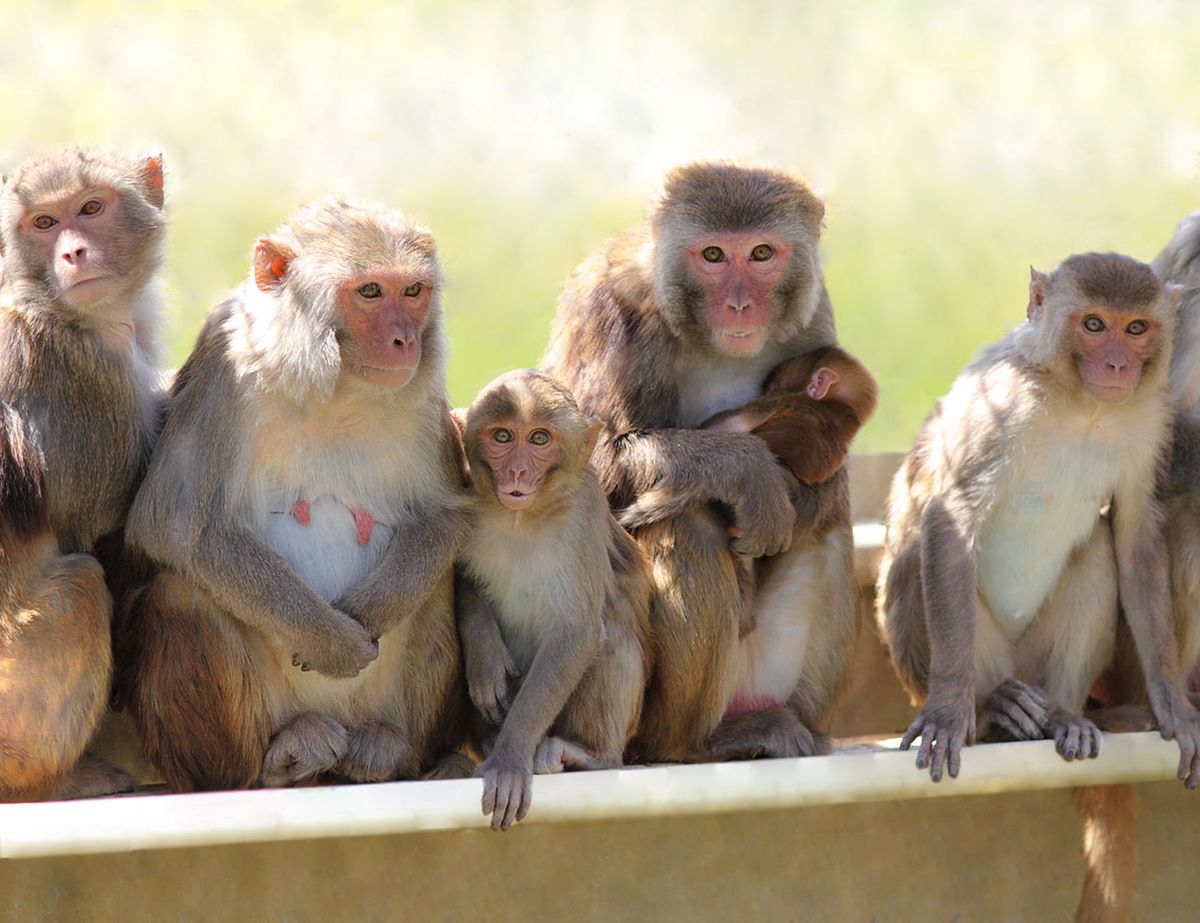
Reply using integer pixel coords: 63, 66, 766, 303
464, 368, 600, 510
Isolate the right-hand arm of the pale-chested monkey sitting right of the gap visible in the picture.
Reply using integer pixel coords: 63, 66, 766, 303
1112, 486, 1200, 789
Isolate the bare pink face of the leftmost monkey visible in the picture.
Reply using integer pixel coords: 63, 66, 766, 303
18, 186, 121, 307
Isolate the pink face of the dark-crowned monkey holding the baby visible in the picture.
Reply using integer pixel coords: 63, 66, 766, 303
686, 230, 792, 355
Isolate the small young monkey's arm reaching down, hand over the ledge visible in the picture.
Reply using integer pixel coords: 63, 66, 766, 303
478, 609, 601, 829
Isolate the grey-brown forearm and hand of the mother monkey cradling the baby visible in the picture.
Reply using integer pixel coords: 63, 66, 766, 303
614, 430, 794, 558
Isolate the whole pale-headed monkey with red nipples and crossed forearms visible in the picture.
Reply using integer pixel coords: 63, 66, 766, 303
126, 200, 469, 790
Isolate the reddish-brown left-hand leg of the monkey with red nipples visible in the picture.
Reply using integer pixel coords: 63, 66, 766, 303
130, 571, 271, 791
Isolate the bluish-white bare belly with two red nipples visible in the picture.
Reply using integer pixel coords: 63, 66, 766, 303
262, 491, 392, 603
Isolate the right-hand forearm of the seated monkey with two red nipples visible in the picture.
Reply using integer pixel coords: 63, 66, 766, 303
334, 497, 470, 640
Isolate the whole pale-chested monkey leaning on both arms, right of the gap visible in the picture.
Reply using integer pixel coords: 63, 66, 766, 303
878, 253, 1200, 787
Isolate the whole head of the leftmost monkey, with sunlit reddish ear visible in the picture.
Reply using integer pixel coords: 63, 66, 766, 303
0, 148, 167, 317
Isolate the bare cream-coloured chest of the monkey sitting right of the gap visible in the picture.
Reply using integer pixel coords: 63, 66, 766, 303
976, 440, 1120, 641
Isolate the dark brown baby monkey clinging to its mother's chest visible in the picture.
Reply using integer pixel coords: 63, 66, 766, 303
703, 346, 878, 486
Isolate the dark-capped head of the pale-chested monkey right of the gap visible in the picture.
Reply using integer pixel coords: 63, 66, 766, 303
1018, 253, 1180, 403
